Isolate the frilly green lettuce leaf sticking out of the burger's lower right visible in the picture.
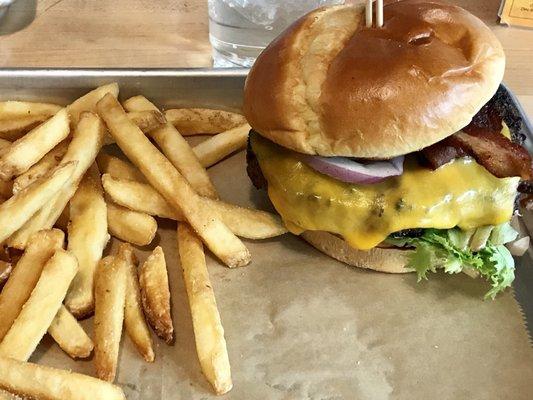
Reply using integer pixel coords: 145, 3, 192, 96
387, 228, 514, 299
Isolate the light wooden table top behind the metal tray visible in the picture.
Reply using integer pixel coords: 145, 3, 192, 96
0, 0, 533, 118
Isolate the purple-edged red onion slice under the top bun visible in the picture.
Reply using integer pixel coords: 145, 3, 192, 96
303, 156, 404, 183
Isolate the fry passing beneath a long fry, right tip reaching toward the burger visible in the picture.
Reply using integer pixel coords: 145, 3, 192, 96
102, 174, 287, 239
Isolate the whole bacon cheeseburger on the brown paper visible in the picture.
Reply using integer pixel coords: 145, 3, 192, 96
244, 0, 532, 297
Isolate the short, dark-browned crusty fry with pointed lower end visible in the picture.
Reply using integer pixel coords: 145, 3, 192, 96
139, 246, 174, 344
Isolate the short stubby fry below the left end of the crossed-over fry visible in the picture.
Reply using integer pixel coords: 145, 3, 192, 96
107, 201, 157, 246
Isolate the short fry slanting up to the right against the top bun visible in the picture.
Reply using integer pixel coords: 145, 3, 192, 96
193, 124, 251, 168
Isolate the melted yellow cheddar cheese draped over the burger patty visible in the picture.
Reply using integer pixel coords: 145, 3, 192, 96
250, 134, 520, 250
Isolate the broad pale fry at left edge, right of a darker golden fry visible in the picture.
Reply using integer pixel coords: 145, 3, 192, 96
0, 249, 78, 361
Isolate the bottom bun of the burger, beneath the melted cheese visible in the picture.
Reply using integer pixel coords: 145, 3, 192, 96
301, 231, 413, 274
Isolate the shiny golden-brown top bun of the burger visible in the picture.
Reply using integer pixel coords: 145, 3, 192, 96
244, 0, 505, 158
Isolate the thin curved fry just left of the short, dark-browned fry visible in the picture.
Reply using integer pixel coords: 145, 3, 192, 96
118, 243, 155, 362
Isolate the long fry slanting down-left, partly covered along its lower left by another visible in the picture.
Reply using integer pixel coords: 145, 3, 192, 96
8, 112, 105, 249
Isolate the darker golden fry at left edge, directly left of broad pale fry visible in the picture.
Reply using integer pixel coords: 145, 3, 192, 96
0, 229, 65, 342
